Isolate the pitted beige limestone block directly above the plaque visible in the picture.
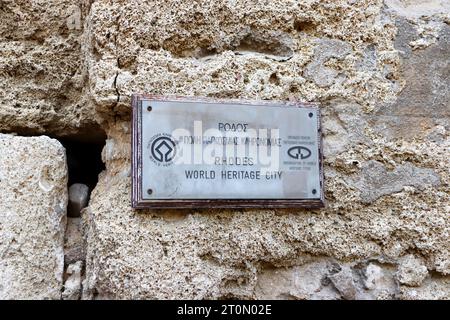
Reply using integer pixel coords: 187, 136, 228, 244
87, 0, 400, 116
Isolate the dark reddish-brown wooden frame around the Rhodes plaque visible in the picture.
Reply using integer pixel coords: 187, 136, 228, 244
131, 94, 325, 209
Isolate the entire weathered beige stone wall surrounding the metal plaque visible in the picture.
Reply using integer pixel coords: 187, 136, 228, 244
0, 0, 450, 299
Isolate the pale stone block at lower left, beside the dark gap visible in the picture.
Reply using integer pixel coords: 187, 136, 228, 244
0, 134, 67, 299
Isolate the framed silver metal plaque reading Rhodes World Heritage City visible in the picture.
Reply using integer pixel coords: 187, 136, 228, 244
132, 95, 324, 208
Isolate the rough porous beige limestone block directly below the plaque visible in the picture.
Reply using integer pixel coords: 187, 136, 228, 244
85, 125, 448, 299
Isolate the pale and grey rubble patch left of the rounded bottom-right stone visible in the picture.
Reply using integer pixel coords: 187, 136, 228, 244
255, 255, 401, 300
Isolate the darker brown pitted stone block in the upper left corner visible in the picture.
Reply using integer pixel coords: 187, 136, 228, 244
0, 0, 99, 138
